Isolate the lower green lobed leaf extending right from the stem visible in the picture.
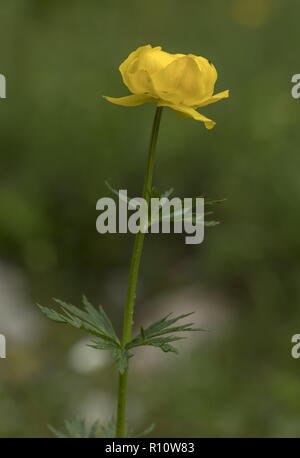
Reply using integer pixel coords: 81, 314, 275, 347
126, 312, 204, 353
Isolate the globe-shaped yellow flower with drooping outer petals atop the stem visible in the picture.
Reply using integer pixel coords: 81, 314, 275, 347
104, 45, 229, 129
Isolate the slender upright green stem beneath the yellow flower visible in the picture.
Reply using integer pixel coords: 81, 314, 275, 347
116, 107, 163, 437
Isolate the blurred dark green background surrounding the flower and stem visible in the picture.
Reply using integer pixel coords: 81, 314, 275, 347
0, 0, 300, 437
